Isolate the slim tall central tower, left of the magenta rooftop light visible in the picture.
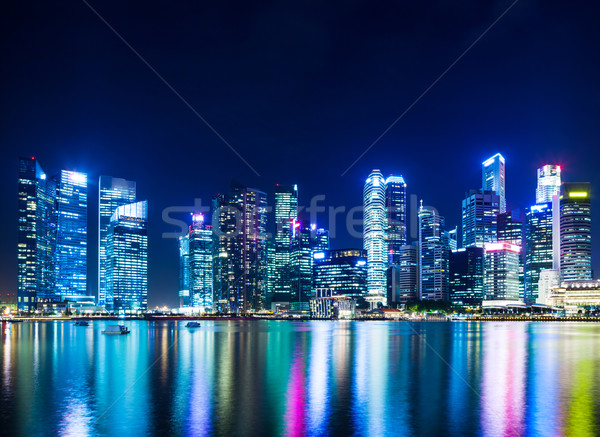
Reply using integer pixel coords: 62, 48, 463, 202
274, 185, 298, 301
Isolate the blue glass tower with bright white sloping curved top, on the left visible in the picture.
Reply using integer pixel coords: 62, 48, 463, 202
106, 201, 148, 313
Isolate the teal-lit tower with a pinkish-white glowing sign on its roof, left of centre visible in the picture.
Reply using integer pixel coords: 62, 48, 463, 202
188, 213, 213, 312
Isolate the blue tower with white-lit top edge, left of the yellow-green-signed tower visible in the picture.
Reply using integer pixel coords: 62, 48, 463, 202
525, 203, 553, 303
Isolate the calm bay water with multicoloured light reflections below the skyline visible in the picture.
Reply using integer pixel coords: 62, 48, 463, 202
0, 321, 600, 436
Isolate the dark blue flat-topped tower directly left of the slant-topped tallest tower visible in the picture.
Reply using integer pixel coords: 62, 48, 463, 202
462, 190, 501, 247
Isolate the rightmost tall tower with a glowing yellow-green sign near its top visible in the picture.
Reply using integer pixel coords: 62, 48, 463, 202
560, 182, 592, 281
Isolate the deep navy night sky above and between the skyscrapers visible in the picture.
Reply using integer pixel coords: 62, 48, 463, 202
0, 0, 600, 306
